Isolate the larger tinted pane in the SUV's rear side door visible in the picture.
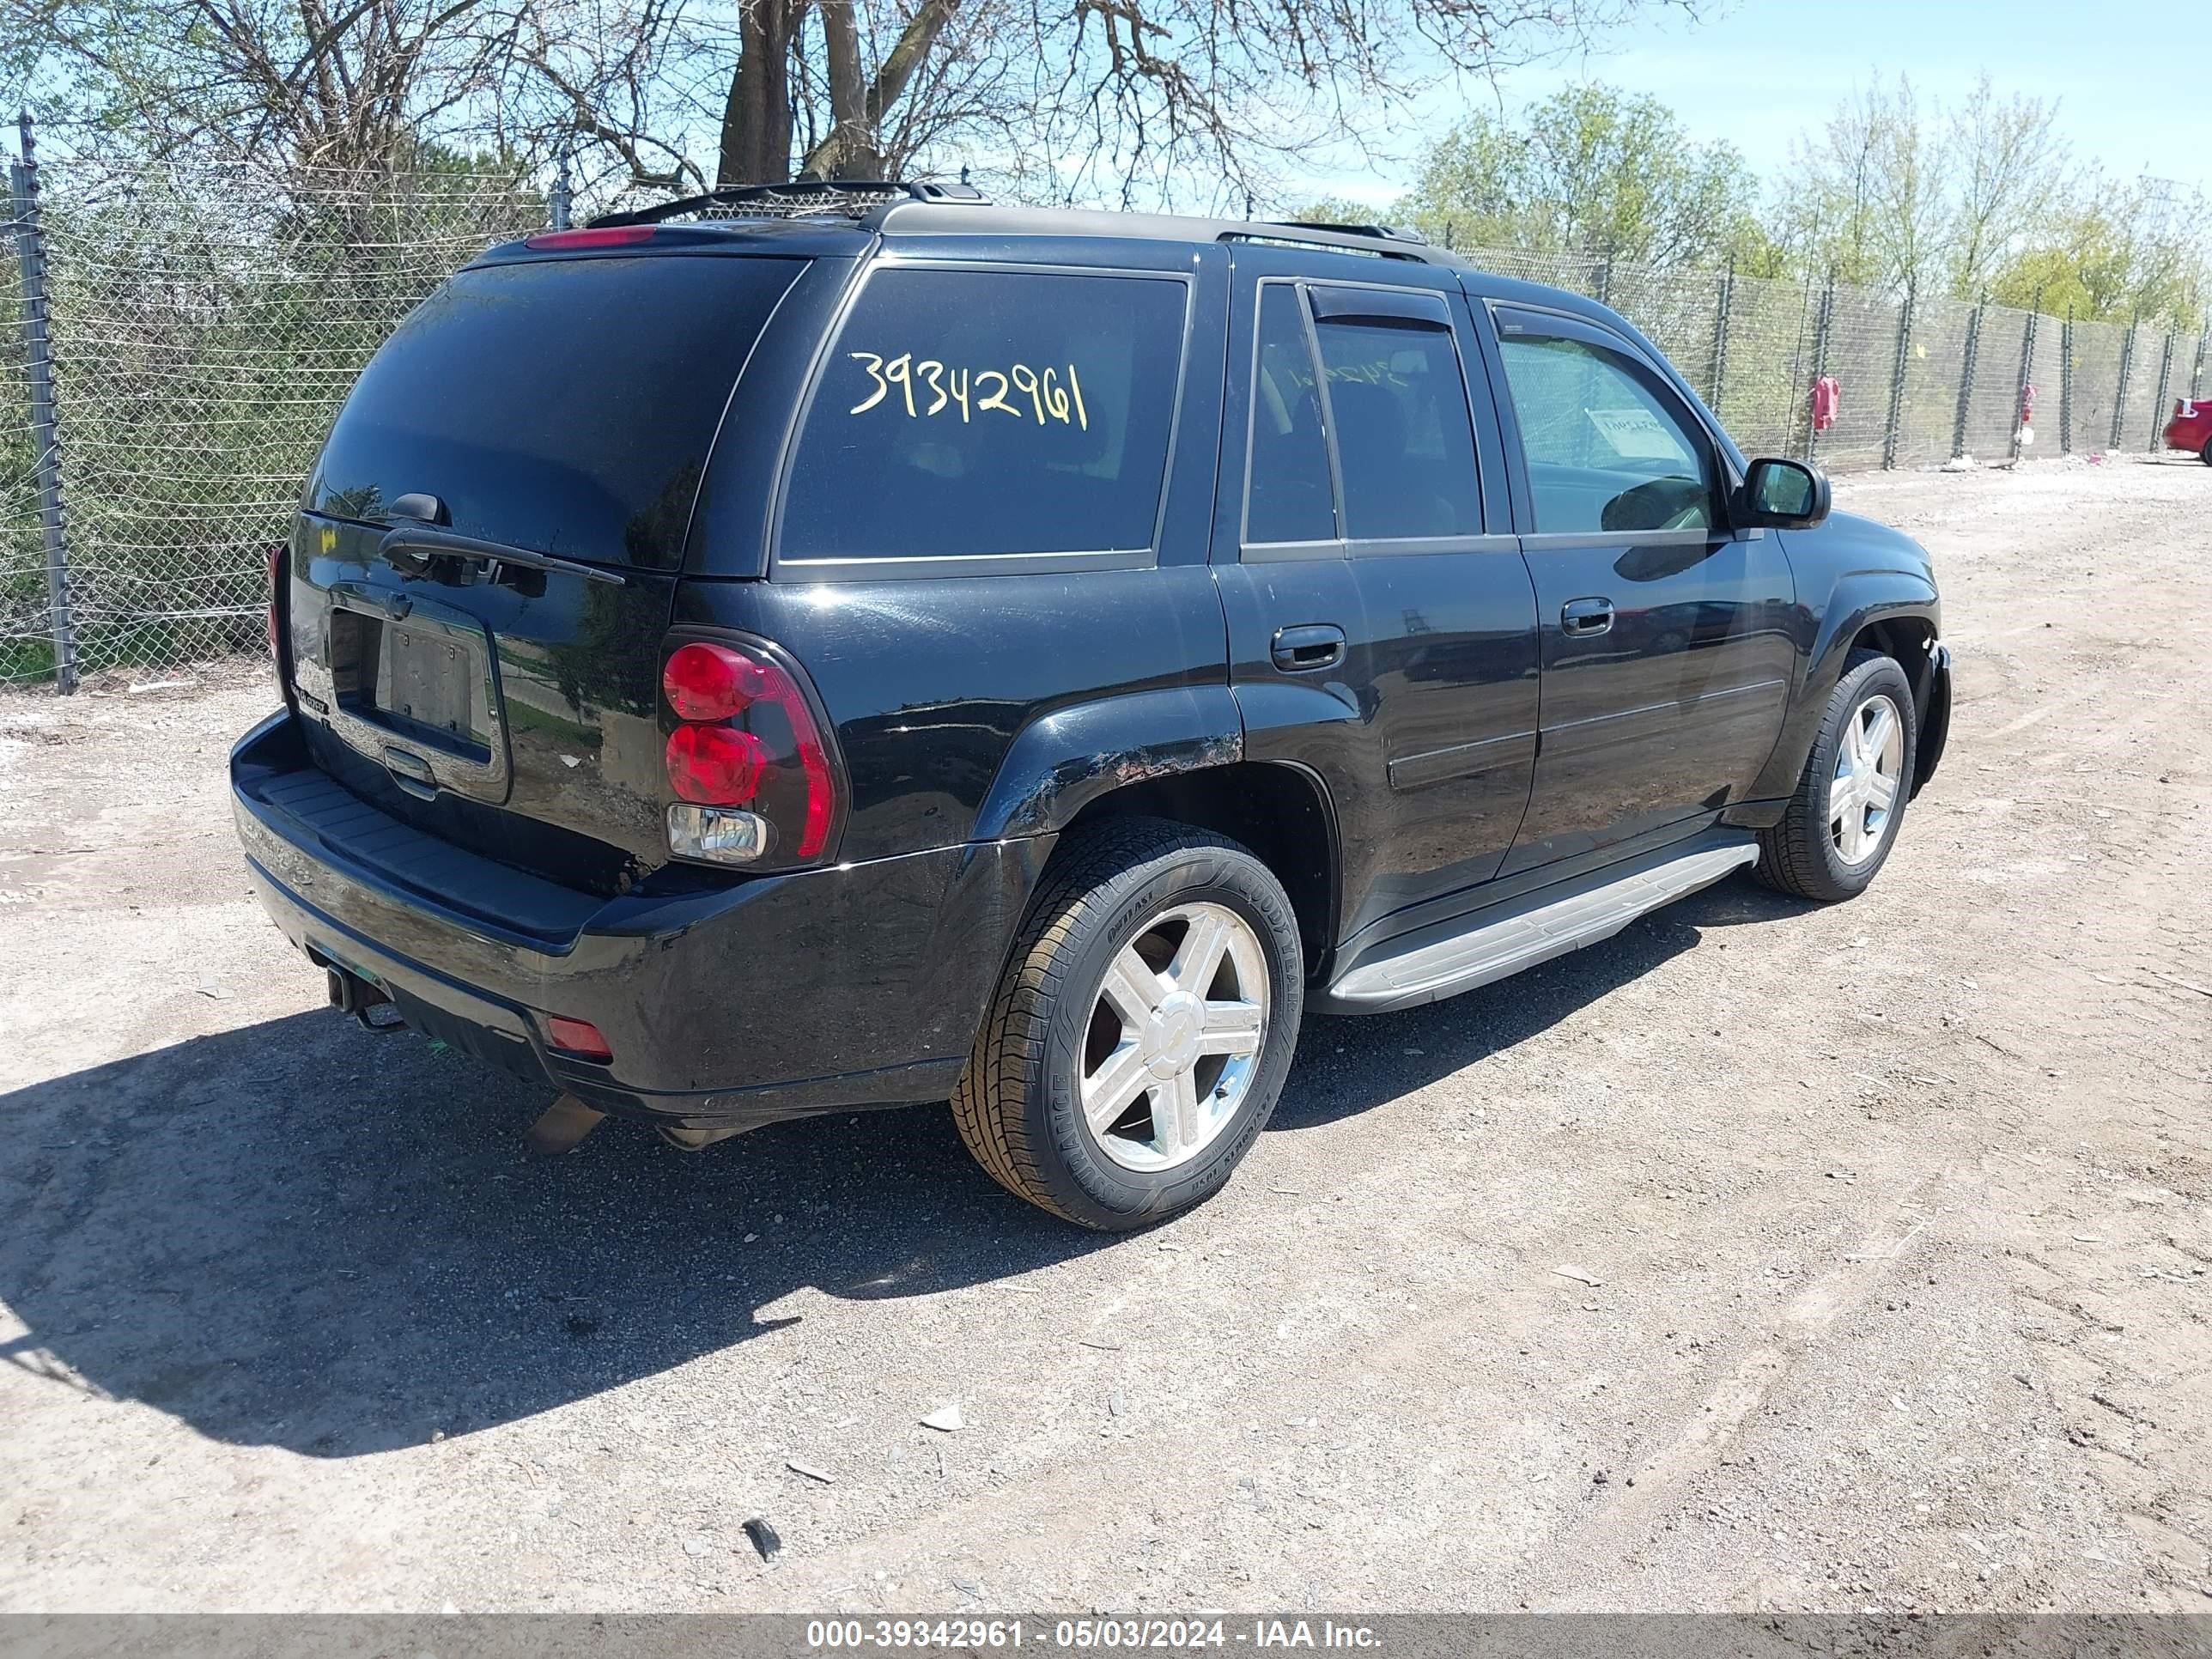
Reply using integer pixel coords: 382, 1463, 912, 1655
1318, 321, 1482, 540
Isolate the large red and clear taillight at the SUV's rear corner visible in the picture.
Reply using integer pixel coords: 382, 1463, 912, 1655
661, 637, 838, 865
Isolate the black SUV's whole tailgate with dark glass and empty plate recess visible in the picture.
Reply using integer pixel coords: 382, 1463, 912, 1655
288, 252, 807, 883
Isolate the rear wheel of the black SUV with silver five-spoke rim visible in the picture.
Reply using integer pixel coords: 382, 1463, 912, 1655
953, 818, 1305, 1232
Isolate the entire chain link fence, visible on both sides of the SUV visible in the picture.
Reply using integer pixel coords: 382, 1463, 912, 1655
0, 138, 2205, 688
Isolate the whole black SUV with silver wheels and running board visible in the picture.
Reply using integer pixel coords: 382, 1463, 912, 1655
232, 185, 1951, 1228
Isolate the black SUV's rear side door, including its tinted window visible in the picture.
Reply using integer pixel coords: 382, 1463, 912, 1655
1214, 248, 1535, 942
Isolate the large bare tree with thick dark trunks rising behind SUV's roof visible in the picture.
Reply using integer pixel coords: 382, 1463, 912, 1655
577, 0, 1692, 201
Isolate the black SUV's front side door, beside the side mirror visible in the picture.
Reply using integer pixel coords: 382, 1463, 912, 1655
1489, 305, 1796, 874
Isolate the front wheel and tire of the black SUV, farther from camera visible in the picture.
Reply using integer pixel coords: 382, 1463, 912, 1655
1759, 650, 1920, 905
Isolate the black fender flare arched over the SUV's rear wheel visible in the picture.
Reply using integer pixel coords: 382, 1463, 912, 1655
971, 684, 1243, 841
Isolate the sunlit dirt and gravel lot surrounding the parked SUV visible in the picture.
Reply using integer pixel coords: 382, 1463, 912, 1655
0, 462, 2212, 1613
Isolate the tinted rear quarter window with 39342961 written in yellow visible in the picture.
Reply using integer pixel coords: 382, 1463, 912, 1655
779, 268, 1188, 560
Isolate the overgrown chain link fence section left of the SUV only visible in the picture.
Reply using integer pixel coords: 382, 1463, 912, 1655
0, 135, 549, 688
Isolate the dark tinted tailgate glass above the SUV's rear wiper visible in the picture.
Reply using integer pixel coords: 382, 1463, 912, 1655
310, 254, 803, 568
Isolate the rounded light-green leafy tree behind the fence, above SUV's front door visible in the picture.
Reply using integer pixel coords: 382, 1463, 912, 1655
1395, 84, 1770, 265
